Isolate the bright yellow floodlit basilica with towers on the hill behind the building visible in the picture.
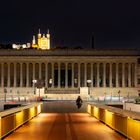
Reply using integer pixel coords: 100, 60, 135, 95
32, 29, 50, 50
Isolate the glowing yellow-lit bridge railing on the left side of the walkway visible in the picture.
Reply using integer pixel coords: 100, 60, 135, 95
0, 103, 42, 139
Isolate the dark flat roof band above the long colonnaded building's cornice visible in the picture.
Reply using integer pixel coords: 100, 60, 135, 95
0, 49, 140, 56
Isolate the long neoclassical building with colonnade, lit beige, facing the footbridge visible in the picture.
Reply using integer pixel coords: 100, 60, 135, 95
0, 49, 140, 99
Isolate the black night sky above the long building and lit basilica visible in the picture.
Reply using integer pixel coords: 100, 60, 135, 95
0, 0, 140, 48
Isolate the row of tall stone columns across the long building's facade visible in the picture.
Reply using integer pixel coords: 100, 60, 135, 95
1, 63, 137, 88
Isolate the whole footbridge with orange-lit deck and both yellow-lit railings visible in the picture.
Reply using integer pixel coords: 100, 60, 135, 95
0, 101, 140, 140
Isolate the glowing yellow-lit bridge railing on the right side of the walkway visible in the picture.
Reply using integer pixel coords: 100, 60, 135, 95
87, 104, 140, 140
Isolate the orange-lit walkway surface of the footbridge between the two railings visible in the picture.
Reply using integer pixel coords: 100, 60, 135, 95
5, 113, 125, 140
